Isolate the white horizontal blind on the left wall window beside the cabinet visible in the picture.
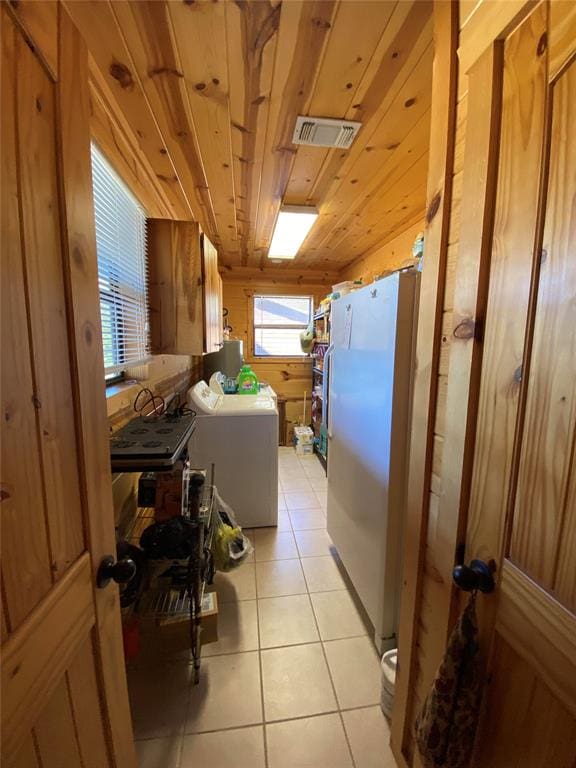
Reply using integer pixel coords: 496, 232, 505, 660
92, 144, 150, 376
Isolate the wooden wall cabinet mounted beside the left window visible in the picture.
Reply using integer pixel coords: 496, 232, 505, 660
148, 219, 222, 355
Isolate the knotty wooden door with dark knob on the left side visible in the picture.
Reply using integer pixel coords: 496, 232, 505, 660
0, 7, 136, 768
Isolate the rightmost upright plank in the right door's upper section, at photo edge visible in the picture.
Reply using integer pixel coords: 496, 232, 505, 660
510, 64, 576, 596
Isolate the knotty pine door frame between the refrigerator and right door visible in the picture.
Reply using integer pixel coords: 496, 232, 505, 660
392, 2, 470, 766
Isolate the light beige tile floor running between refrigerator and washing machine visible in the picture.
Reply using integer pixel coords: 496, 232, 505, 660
129, 448, 396, 768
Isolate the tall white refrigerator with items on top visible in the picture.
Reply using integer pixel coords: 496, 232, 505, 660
327, 272, 420, 650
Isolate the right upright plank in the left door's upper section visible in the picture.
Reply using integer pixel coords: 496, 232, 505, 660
16, 25, 84, 579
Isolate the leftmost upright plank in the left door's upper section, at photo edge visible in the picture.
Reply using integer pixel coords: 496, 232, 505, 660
1, 12, 52, 634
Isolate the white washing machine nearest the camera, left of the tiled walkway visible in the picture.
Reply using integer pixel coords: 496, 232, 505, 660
187, 381, 278, 528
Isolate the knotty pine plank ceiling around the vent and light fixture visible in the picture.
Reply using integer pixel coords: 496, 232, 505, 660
66, 0, 433, 270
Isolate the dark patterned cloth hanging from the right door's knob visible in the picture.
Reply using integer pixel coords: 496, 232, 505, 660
415, 595, 481, 768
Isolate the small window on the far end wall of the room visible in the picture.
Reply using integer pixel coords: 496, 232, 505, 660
254, 296, 312, 357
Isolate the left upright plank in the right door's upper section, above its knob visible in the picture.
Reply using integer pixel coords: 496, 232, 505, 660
467, 1, 547, 576
